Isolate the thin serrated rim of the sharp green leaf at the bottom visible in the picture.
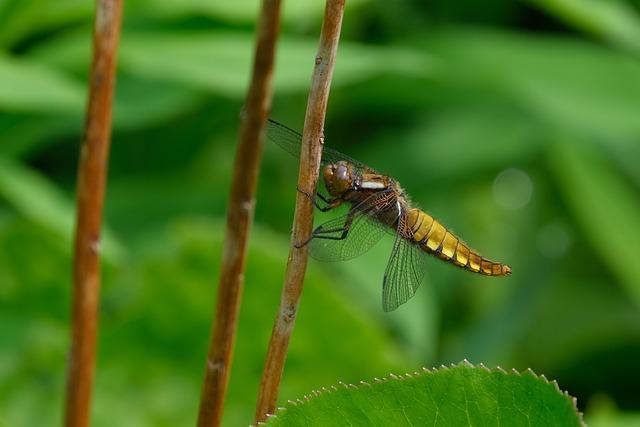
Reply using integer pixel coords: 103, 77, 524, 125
251, 359, 586, 427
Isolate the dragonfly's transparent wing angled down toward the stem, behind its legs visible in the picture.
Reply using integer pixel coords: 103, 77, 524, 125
310, 191, 397, 262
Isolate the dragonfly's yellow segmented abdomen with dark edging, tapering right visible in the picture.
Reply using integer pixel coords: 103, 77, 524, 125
405, 209, 511, 276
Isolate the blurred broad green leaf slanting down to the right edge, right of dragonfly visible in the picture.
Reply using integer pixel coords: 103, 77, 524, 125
550, 140, 640, 303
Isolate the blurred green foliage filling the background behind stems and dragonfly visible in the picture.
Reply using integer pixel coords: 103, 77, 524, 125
0, 0, 640, 426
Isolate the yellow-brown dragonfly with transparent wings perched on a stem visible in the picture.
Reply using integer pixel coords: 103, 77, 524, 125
267, 120, 511, 312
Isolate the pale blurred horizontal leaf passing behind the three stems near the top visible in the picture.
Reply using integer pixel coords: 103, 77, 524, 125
28, 31, 433, 98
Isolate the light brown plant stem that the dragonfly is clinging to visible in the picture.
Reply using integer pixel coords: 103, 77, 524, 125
256, 0, 345, 423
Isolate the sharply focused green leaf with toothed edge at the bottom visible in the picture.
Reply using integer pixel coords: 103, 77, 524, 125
266, 362, 584, 427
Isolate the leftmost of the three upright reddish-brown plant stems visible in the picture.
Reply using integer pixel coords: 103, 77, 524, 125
65, 0, 122, 427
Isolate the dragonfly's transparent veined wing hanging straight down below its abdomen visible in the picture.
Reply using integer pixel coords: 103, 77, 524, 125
382, 216, 424, 311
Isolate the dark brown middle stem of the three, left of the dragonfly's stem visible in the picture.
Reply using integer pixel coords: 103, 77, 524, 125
198, 0, 281, 427
